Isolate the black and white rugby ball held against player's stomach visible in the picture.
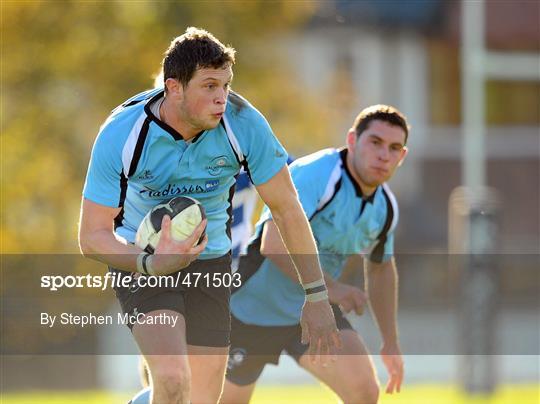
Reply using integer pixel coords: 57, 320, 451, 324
135, 196, 206, 254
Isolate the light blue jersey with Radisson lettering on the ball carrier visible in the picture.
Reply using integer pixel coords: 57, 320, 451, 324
83, 89, 287, 259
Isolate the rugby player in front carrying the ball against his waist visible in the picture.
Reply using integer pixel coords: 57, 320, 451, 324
79, 27, 339, 403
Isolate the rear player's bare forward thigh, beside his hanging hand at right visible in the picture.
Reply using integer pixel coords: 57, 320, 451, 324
298, 329, 378, 397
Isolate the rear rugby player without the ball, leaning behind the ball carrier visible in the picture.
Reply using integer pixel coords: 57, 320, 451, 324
222, 105, 409, 404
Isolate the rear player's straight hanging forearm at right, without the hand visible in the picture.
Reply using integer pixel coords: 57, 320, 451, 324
366, 259, 398, 344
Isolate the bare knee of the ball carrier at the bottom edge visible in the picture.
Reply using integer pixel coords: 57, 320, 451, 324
151, 362, 191, 402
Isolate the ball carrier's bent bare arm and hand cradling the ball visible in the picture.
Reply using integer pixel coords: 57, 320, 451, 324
79, 198, 207, 275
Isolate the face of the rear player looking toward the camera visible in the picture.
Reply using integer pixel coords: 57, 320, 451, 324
347, 120, 407, 188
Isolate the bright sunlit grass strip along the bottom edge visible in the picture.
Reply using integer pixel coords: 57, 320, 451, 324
0, 384, 540, 404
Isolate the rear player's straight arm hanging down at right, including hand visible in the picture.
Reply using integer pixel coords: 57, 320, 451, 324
364, 258, 403, 393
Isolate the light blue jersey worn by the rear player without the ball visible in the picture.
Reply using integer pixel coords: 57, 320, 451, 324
231, 149, 398, 326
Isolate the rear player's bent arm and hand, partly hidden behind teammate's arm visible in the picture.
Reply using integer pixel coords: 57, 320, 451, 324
261, 220, 367, 314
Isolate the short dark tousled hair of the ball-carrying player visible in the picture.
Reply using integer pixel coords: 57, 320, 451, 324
163, 27, 235, 87
